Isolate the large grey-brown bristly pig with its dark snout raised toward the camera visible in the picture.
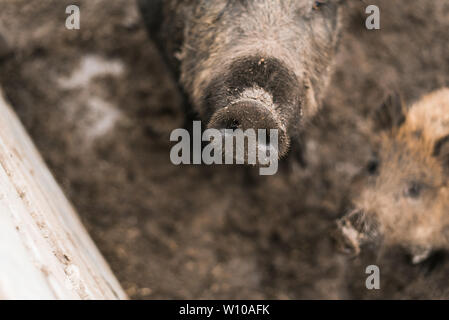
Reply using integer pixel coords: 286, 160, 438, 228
138, 0, 343, 156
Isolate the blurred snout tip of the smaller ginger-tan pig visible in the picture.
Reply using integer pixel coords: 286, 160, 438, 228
332, 210, 382, 256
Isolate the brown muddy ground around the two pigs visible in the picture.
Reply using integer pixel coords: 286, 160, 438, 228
0, 0, 449, 299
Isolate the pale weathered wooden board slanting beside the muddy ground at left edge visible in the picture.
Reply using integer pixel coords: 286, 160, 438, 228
0, 90, 126, 299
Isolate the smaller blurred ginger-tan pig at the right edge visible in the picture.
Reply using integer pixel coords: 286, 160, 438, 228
336, 88, 449, 263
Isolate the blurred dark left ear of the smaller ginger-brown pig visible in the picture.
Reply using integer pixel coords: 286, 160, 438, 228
373, 92, 406, 130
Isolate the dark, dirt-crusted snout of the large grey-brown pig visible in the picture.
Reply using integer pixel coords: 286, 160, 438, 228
203, 55, 305, 158
